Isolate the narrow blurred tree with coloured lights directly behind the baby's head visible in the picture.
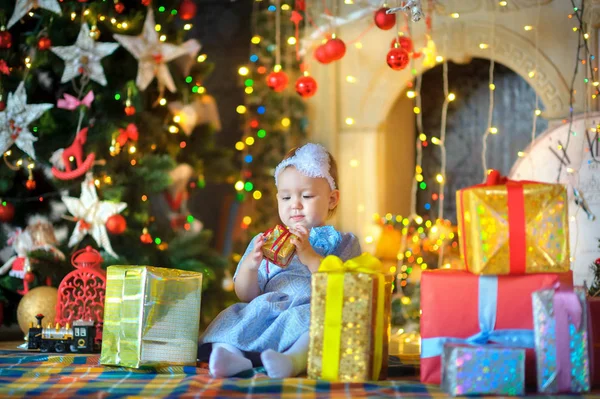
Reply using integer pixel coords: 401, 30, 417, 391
235, 1, 316, 253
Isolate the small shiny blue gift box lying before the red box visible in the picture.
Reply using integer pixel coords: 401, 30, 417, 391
442, 343, 525, 396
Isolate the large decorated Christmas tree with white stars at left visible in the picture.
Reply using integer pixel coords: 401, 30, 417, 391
0, 0, 239, 324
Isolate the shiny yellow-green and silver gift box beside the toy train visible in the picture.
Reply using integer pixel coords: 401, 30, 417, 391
100, 266, 202, 368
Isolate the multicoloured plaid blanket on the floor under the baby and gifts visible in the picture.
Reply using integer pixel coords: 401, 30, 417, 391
0, 352, 592, 399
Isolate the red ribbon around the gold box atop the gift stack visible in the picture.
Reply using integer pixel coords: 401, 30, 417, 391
459, 170, 539, 274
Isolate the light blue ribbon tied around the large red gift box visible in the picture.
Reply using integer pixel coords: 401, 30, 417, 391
421, 276, 534, 358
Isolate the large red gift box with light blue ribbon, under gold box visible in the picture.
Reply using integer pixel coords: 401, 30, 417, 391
421, 269, 573, 384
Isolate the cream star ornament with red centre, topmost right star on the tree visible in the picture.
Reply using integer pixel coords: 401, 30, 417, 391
113, 9, 200, 93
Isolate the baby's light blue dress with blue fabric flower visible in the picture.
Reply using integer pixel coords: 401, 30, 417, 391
200, 226, 361, 353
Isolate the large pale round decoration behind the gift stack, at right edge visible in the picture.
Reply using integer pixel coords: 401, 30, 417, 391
509, 113, 600, 287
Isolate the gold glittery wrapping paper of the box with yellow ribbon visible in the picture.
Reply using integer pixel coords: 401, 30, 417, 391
307, 254, 394, 382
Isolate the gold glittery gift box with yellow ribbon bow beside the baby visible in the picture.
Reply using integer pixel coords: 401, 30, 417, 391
308, 253, 394, 382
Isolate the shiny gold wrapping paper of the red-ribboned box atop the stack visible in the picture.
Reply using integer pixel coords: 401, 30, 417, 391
456, 182, 570, 275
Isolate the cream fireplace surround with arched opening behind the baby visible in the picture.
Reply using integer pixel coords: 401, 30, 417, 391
310, 0, 600, 249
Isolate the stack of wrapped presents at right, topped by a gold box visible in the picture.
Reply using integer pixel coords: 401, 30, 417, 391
421, 171, 591, 395
